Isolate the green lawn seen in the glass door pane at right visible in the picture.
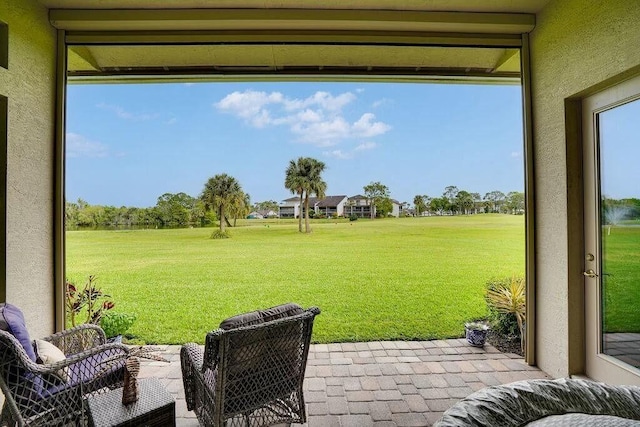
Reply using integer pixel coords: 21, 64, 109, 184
602, 226, 640, 332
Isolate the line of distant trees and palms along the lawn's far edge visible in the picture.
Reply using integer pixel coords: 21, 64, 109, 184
65, 157, 525, 231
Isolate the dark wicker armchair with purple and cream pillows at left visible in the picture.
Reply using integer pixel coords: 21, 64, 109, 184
0, 325, 128, 426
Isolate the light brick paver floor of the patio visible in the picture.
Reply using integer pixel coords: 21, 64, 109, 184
140, 339, 549, 427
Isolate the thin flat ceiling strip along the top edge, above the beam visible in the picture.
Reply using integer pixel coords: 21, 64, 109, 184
40, 0, 549, 13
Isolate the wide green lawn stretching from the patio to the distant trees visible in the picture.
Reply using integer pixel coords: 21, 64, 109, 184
66, 215, 525, 344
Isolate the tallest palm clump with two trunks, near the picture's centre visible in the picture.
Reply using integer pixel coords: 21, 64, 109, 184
284, 157, 327, 233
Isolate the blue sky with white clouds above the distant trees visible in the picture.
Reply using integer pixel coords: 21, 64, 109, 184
66, 82, 524, 207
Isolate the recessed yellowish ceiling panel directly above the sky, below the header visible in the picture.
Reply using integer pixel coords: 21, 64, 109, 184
68, 45, 520, 78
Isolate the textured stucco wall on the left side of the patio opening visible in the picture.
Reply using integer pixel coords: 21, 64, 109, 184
0, 0, 56, 336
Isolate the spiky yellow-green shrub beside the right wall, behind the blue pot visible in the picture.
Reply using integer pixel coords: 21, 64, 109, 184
486, 276, 526, 349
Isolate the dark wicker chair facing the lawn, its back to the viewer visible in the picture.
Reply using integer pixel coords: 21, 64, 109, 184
180, 304, 320, 427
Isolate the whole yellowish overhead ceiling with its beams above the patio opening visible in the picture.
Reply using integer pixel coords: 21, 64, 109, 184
48, 0, 536, 81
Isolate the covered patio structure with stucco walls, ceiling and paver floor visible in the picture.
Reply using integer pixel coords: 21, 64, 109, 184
0, 0, 640, 426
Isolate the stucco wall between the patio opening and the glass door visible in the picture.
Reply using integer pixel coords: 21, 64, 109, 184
531, 0, 640, 377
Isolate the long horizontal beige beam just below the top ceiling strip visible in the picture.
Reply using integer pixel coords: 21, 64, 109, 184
49, 9, 535, 34
